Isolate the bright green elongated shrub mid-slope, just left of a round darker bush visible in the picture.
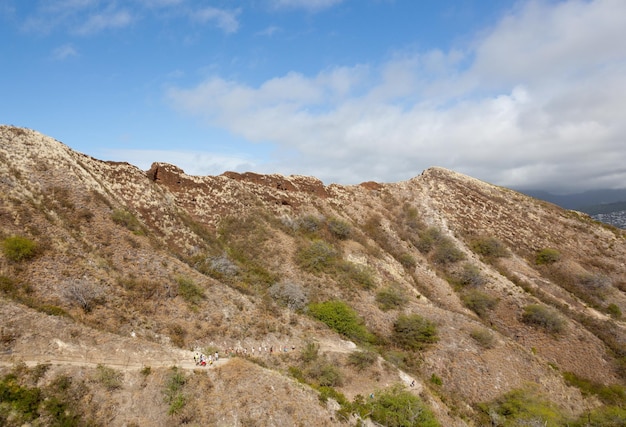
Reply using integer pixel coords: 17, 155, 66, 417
309, 300, 374, 342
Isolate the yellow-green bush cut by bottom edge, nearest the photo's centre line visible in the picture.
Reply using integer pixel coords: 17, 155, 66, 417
355, 385, 439, 427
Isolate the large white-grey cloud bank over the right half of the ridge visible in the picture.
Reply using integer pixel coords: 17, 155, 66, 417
167, 0, 626, 191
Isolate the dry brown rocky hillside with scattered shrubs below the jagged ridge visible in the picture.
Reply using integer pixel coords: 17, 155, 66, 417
0, 126, 626, 425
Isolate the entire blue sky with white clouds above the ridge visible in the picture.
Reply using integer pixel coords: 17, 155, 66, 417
0, 0, 626, 192
